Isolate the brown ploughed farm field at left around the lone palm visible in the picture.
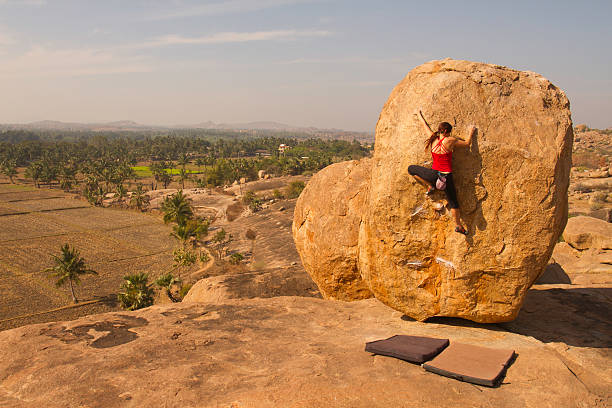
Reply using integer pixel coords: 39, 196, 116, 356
0, 184, 175, 330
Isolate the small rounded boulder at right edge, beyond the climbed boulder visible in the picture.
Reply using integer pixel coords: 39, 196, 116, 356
563, 216, 612, 250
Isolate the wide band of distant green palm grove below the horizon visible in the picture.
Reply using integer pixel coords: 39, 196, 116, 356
0, 130, 370, 192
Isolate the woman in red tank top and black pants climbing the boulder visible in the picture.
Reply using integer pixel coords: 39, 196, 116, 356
408, 110, 476, 235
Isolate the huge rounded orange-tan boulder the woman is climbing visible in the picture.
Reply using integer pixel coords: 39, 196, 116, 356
359, 59, 573, 322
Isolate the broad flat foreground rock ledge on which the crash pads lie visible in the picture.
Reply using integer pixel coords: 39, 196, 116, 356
0, 289, 612, 408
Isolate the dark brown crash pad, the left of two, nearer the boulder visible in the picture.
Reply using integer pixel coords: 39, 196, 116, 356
366, 335, 448, 364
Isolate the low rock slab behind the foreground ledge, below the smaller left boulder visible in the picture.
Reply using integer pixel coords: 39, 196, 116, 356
183, 268, 320, 303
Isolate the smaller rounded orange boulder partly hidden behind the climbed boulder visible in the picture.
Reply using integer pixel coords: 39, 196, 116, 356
293, 159, 372, 301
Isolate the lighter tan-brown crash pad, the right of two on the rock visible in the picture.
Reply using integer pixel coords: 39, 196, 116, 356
423, 342, 515, 387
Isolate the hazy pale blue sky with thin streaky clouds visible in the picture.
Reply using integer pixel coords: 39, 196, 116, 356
0, 0, 612, 132
